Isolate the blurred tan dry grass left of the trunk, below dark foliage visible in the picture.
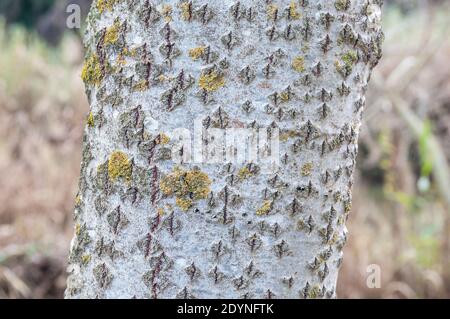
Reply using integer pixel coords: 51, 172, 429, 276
0, 21, 88, 298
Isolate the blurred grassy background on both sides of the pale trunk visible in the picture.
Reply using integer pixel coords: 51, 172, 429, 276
0, 0, 450, 298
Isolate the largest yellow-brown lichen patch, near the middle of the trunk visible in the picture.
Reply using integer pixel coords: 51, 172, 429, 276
159, 168, 211, 210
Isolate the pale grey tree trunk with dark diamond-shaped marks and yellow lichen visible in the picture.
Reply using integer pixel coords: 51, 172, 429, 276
66, 0, 383, 298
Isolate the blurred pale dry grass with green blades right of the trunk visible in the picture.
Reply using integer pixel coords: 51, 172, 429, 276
338, 7, 450, 298
